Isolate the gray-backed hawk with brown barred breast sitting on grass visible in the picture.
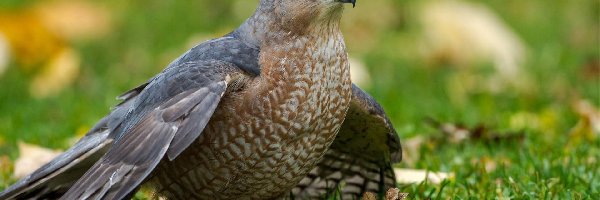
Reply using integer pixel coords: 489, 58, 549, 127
0, 0, 402, 200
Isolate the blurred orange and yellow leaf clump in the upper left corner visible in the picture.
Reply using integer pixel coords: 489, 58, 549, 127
0, 1, 94, 98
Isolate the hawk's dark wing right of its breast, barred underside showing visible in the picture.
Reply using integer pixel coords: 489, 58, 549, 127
291, 85, 402, 199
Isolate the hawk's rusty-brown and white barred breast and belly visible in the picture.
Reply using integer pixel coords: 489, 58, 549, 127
149, 35, 351, 199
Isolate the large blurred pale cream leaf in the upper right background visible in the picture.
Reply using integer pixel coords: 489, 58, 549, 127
420, 0, 526, 80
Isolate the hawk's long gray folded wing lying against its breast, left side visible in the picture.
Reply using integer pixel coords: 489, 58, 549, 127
62, 60, 241, 199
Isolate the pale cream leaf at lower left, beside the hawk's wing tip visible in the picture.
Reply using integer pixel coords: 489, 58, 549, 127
13, 142, 62, 178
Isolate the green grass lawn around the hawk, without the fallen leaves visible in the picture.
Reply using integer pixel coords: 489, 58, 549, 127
0, 0, 600, 199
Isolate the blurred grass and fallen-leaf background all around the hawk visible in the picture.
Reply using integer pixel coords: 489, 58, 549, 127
0, 0, 600, 199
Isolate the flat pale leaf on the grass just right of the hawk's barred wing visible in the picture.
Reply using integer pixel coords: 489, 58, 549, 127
394, 168, 454, 184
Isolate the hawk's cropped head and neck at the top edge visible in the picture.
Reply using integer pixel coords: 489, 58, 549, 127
236, 0, 356, 46
